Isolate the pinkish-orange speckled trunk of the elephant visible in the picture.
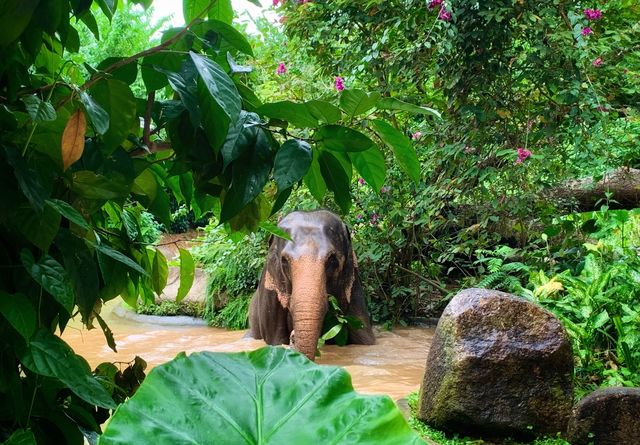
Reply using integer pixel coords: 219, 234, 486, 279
290, 264, 327, 360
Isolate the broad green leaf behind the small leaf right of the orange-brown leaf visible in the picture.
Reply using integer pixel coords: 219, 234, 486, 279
91, 79, 140, 152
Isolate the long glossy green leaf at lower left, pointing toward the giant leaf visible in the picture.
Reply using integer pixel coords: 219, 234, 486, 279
19, 329, 116, 409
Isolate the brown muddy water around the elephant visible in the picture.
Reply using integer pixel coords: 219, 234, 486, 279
62, 302, 433, 400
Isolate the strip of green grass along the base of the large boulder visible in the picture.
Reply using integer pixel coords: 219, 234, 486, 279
407, 392, 571, 445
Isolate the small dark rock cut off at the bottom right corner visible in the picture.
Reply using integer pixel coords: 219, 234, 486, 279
567, 388, 640, 445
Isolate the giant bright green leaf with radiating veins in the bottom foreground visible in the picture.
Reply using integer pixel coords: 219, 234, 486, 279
99, 347, 424, 445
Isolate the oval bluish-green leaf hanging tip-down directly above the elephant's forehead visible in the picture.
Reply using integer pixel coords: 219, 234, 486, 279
273, 139, 313, 191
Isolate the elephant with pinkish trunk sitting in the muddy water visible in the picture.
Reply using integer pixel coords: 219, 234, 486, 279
248, 210, 375, 360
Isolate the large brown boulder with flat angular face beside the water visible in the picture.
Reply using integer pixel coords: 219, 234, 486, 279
418, 289, 573, 437
